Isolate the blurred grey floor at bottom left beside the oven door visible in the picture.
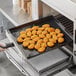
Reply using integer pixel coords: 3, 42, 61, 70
0, 52, 25, 76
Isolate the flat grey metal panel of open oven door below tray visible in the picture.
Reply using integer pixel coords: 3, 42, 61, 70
28, 49, 69, 73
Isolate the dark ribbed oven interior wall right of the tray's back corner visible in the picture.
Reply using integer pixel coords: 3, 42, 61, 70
56, 15, 74, 37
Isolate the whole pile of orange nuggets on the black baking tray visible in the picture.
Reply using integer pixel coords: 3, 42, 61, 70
17, 24, 64, 53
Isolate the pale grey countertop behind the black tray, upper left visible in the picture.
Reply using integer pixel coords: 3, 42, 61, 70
0, 0, 32, 26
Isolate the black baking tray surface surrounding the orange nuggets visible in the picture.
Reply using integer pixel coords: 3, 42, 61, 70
7, 16, 71, 58
